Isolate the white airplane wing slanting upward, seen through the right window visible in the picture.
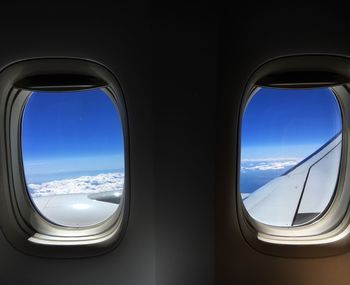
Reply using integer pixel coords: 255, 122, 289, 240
242, 133, 342, 226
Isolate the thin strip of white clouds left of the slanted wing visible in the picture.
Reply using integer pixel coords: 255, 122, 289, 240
241, 159, 299, 171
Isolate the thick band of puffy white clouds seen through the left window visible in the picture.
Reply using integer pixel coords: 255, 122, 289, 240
27, 172, 124, 198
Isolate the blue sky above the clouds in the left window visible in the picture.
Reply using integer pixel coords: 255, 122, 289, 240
22, 89, 124, 182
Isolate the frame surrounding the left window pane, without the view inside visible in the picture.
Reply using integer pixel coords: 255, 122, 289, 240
0, 58, 130, 258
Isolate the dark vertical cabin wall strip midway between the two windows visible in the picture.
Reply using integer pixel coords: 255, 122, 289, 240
152, 1, 219, 285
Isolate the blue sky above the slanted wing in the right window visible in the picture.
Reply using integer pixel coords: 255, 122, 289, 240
241, 87, 342, 160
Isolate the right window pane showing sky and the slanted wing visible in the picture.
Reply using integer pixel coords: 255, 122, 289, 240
240, 87, 342, 227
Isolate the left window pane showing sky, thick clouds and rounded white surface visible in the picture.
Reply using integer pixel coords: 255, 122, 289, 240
21, 89, 124, 227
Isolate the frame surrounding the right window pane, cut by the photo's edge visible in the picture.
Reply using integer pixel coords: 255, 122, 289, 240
236, 55, 350, 257
